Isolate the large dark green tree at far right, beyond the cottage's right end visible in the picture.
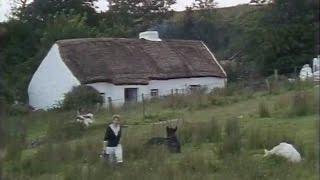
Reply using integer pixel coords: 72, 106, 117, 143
243, 0, 318, 74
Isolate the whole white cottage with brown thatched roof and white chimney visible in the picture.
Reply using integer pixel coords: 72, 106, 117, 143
28, 31, 227, 109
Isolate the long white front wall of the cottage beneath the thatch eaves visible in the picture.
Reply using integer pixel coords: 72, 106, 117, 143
87, 77, 226, 105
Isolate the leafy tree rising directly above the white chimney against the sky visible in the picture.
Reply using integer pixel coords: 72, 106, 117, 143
103, 0, 176, 37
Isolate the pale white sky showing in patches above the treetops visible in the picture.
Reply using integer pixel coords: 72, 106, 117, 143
0, 0, 250, 22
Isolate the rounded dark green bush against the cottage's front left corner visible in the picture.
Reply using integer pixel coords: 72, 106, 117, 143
62, 85, 104, 110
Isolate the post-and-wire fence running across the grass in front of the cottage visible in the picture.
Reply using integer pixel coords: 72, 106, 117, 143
95, 70, 316, 123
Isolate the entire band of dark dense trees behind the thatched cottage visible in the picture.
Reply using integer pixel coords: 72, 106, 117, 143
0, 0, 319, 103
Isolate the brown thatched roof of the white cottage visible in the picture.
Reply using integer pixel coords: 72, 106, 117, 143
57, 38, 226, 85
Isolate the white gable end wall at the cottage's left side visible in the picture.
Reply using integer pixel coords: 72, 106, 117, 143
28, 44, 80, 109
